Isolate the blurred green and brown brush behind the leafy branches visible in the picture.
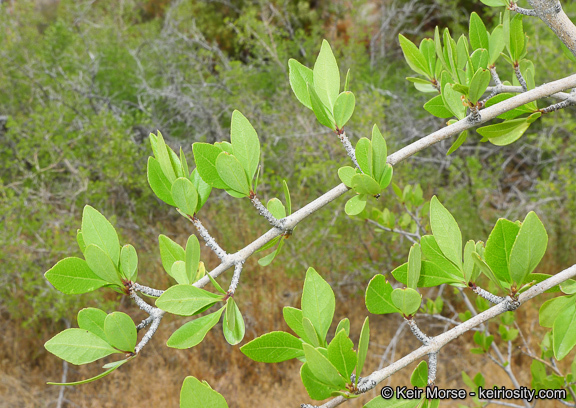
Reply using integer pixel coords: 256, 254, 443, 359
0, 0, 576, 407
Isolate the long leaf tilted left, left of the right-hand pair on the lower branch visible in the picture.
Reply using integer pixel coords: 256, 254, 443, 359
430, 196, 462, 270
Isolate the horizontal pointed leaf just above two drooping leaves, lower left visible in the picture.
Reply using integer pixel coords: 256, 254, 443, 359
156, 285, 223, 316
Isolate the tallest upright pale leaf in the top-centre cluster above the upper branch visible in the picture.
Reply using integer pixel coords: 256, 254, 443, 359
312, 40, 340, 111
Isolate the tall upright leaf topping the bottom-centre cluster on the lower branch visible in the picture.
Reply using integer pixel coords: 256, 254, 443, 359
302, 268, 336, 341
